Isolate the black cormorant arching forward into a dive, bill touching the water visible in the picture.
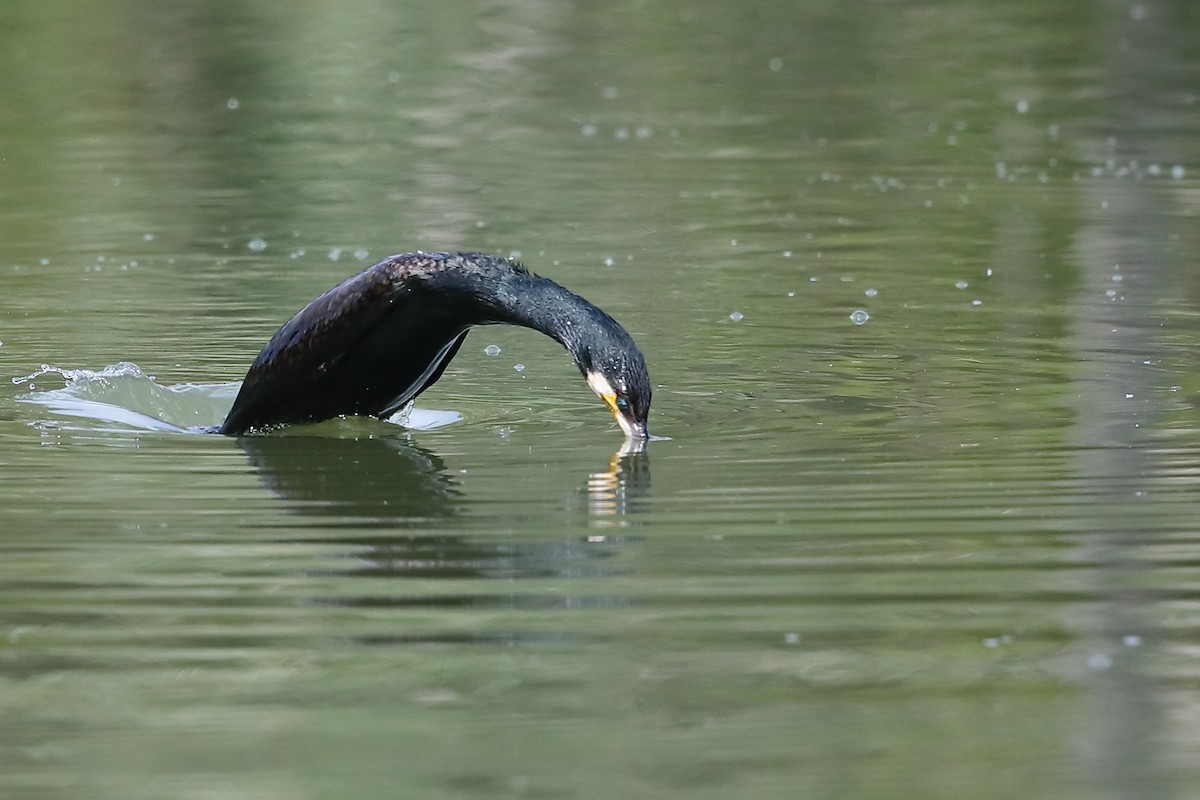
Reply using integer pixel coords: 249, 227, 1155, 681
217, 252, 650, 441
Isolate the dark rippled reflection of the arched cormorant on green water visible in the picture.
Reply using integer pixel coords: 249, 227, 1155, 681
239, 435, 650, 585
